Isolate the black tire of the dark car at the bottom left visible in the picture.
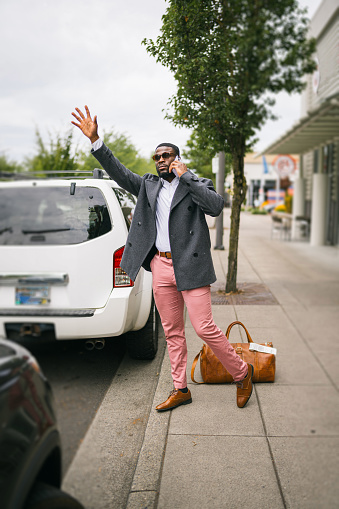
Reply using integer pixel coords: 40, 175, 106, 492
25, 482, 84, 509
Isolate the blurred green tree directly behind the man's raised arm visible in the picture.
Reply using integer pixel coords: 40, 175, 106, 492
79, 131, 156, 175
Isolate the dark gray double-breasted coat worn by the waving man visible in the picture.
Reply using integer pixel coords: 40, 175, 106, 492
92, 145, 224, 291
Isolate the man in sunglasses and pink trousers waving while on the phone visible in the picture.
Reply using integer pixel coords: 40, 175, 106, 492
72, 106, 253, 412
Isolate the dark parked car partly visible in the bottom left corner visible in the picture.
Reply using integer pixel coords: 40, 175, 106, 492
0, 339, 83, 509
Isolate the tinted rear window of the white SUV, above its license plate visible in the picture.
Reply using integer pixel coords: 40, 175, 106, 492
0, 186, 112, 245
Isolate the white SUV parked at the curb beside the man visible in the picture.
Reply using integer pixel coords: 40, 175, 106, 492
0, 170, 158, 359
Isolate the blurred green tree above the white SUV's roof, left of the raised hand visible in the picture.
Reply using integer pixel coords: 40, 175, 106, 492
25, 129, 77, 177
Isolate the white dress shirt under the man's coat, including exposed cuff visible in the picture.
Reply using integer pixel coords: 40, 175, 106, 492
92, 138, 179, 251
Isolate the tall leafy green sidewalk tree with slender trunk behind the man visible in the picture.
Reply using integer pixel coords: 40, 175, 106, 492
143, 0, 315, 292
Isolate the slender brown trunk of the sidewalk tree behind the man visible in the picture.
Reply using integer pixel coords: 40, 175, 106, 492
226, 147, 247, 293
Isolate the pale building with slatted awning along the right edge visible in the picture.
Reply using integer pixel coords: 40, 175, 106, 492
264, 0, 339, 246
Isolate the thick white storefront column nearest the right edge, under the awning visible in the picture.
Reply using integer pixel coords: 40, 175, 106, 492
311, 173, 328, 246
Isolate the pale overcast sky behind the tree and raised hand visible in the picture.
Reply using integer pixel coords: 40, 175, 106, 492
0, 0, 321, 161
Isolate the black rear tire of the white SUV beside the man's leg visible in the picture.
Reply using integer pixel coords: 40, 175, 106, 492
126, 297, 160, 360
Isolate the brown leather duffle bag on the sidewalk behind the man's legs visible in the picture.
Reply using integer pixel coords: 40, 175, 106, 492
191, 321, 275, 384
